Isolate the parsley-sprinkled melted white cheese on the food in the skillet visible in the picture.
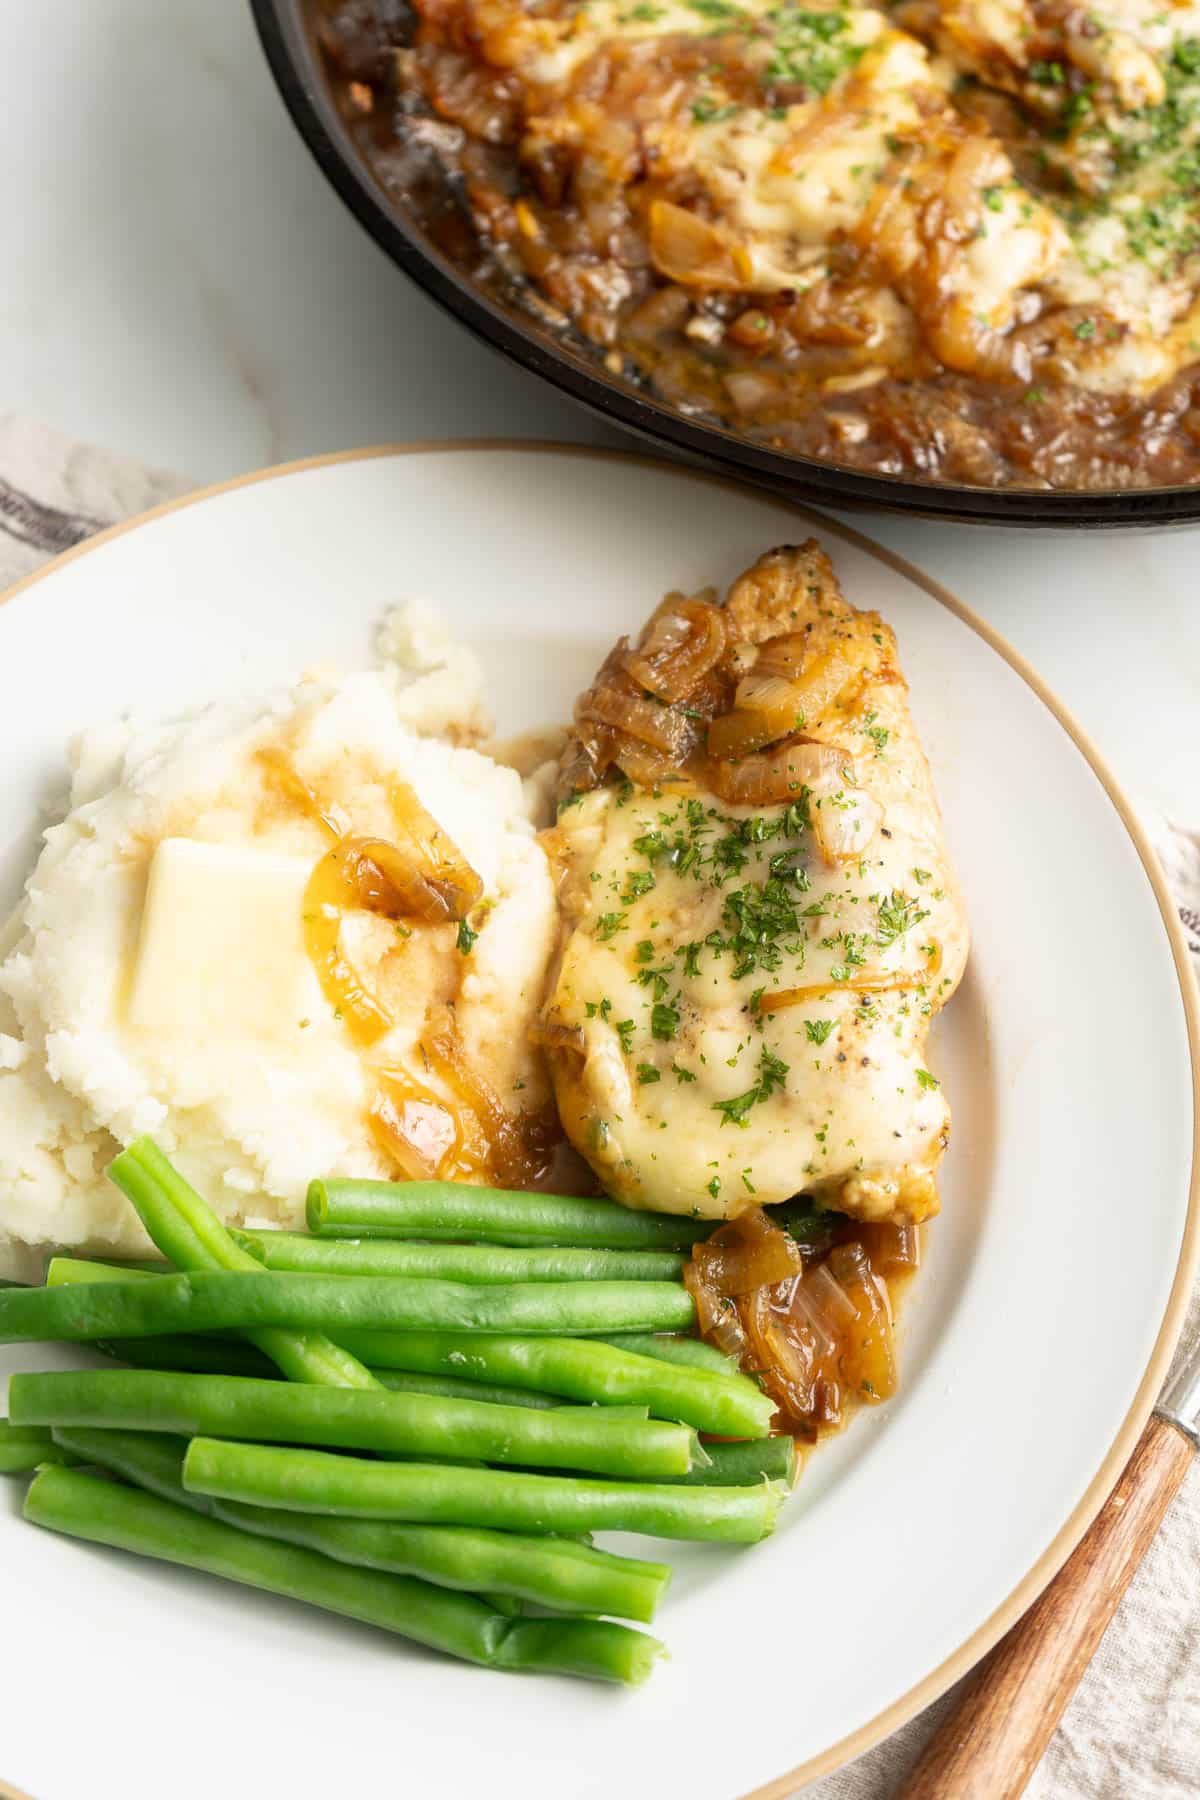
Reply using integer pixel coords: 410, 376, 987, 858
520, 0, 1200, 392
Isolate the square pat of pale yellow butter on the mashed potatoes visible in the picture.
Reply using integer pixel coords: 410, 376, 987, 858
130, 837, 324, 1048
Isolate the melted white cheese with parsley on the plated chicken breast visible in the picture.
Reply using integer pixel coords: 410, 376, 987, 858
545, 545, 966, 1219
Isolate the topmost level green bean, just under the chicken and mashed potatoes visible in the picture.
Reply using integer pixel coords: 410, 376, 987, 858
308, 1181, 696, 1251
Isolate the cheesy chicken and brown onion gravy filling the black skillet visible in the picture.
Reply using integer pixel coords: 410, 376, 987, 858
313, 0, 1200, 490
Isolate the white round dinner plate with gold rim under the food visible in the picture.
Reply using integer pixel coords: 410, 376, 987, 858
0, 446, 1196, 1800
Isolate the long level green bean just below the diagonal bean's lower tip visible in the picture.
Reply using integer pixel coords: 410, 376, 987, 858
9, 1370, 705, 1480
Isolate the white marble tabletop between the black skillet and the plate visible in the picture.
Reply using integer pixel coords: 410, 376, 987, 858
0, 0, 1200, 823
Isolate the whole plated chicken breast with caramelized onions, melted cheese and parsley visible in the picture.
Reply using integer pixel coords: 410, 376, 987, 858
542, 540, 968, 1220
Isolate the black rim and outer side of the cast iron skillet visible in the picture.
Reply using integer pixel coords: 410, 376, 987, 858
250, 0, 1200, 529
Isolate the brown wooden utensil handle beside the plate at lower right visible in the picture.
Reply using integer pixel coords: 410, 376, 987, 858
896, 1418, 1193, 1800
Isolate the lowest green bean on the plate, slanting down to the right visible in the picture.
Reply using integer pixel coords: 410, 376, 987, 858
25, 1463, 662, 1683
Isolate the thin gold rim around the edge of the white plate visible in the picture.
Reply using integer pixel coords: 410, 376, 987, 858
0, 437, 1200, 1800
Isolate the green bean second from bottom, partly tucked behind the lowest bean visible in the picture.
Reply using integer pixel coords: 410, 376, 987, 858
47, 1426, 647, 1624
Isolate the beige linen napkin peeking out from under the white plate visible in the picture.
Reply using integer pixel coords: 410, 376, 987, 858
0, 418, 1200, 1800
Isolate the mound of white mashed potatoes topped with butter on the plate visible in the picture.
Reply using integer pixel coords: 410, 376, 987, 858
0, 608, 554, 1273
